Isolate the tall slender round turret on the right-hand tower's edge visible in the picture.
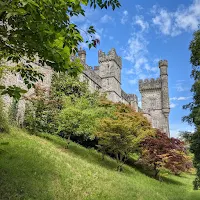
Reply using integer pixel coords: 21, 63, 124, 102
159, 60, 170, 135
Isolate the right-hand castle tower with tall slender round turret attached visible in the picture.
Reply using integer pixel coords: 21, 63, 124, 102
139, 60, 170, 136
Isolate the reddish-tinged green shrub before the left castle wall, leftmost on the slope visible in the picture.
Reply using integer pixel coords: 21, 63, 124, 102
24, 86, 58, 133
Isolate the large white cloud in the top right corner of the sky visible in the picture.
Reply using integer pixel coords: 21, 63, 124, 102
152, 0, 200, 37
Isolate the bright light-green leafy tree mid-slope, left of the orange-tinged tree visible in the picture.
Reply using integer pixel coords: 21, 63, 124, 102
58, 92, 109, 147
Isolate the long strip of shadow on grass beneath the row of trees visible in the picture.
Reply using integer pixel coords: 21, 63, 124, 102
24, 133, 189, 185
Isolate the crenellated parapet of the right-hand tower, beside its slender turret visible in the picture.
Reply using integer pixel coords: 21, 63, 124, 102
139, 78, 162, 91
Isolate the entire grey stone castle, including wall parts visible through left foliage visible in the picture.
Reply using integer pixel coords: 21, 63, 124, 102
3, 48, 170, 135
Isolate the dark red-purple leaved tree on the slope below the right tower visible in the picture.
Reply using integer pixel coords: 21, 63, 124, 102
141, 130, 191, 179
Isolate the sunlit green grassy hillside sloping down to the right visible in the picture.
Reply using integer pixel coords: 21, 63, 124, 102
0, 129, 200, 200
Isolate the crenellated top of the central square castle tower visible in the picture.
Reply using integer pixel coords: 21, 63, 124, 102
98, 48, 122, 68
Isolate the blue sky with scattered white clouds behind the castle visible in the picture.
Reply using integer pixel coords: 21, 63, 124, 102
72, 0, 200, 137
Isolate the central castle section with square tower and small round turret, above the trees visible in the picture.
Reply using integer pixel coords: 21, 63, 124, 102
78, 49, 138, 111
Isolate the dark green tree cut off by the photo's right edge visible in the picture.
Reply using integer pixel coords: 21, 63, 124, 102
183, 27, 200, 189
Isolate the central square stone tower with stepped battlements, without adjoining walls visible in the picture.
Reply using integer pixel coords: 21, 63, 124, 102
98, 48, 122, 102
